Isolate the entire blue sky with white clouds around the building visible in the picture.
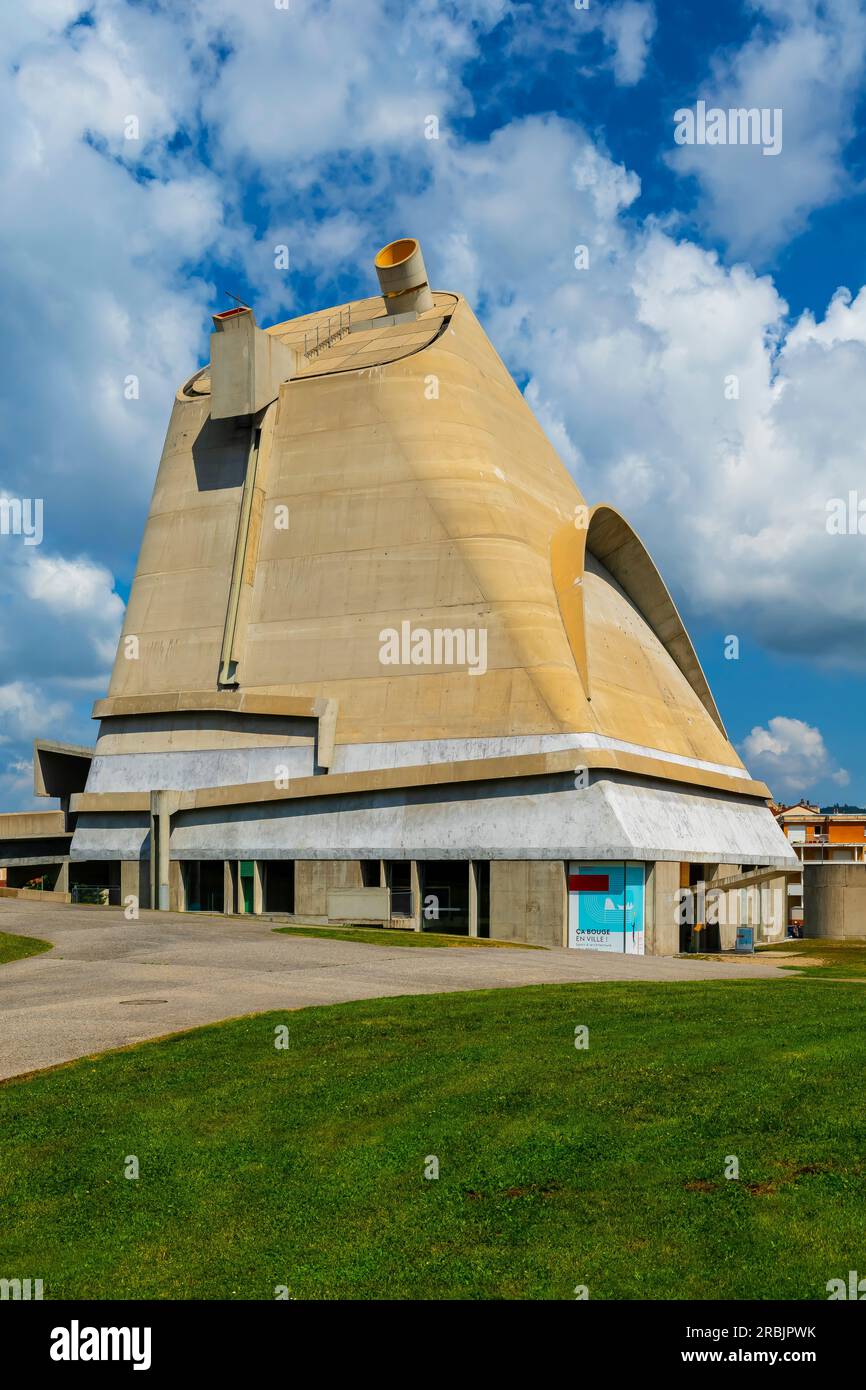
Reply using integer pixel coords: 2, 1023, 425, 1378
0, 0, 866, 809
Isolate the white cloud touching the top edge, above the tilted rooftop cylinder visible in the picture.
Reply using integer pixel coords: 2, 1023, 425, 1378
195, 0, 506, 173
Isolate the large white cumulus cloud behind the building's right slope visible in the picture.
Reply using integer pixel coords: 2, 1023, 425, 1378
383, 117, 866, 669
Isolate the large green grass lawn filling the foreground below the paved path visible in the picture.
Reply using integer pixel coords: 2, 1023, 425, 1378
0, 977, 866, 1300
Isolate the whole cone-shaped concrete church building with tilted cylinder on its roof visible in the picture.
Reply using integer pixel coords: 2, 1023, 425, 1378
0, 239, 794, 954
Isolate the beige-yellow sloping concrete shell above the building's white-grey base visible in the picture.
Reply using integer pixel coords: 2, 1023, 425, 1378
103, 296, 742, 770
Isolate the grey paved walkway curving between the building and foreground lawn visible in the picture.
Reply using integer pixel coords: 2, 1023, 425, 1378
0, 899, 784, 1077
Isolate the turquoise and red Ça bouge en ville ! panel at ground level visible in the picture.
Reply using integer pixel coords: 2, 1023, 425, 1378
569, 860, 644, 955
